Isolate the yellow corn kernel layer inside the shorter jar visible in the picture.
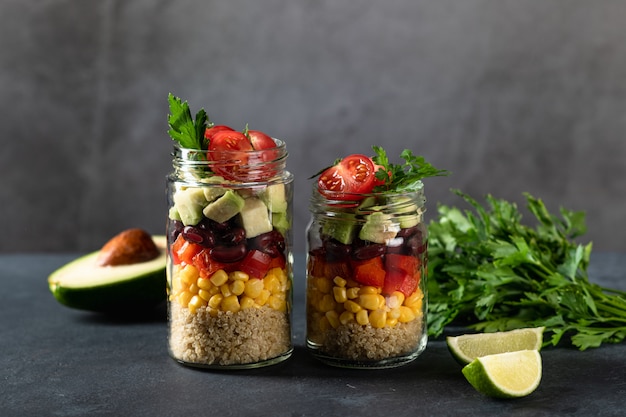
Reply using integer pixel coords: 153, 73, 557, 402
307, 276, 424, 331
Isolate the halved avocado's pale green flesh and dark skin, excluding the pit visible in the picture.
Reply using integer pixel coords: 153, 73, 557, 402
48, 236, 167, 313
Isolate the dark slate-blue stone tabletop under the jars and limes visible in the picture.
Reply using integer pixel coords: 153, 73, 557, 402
0, 253, 626, 417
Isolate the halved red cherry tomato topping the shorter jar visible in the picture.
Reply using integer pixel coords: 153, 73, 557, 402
317, 154, 376, 200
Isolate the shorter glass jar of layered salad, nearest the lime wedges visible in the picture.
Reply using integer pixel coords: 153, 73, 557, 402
306, 185, 427, 368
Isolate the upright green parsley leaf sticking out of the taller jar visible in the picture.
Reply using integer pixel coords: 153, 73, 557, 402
167, 93, 209, 150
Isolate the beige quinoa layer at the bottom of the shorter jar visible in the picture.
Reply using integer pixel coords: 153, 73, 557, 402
316, 318, 424, 361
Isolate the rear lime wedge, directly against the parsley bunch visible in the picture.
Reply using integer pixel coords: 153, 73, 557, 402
446, 327, 545, 365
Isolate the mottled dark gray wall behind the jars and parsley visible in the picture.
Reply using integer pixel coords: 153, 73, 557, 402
0, 0, 626, 252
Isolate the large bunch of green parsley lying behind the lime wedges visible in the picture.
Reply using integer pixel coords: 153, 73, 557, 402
428, 191, 626, 350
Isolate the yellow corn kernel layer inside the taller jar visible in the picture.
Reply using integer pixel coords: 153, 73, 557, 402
169, 264, 291, 314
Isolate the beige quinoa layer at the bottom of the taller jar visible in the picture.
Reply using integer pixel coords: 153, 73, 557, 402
169, 303, 291, 366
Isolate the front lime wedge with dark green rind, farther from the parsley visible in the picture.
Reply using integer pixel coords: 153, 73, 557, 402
463, 350, 541, 398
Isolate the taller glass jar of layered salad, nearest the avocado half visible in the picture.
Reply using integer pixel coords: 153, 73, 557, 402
167, 139, 293, 369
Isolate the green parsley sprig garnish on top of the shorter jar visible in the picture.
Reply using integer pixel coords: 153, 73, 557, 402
372, 146, 450, 193
